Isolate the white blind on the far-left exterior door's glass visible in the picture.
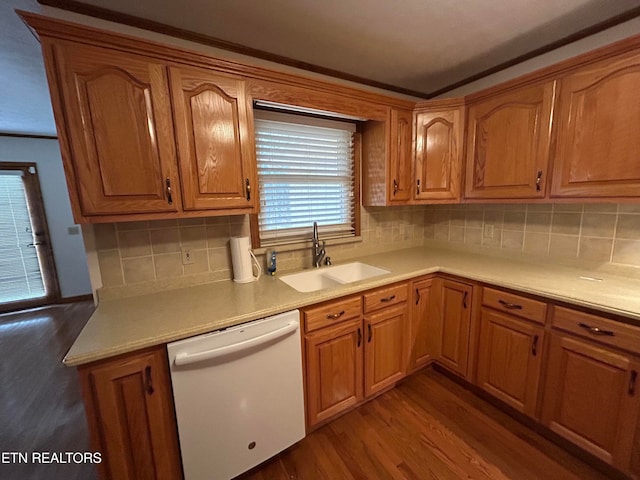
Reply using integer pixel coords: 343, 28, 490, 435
0, 170, 46, 303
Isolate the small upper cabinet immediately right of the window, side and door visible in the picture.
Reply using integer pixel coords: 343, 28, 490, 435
362, 108, 413, 207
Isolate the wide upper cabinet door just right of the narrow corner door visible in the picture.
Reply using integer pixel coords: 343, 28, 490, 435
465, 82, 555, 198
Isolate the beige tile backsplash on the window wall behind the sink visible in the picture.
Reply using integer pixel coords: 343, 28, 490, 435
93, 207, 426, 300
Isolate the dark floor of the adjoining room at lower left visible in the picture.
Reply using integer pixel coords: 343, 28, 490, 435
0, 301, 97, 480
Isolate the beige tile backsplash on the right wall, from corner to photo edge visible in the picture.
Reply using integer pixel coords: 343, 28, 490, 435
424, 204, 640, 276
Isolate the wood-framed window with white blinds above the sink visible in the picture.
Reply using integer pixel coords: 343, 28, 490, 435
255, 111, 359, 247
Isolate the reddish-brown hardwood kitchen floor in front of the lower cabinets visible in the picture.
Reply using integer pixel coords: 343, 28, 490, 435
236, 369, 624, 480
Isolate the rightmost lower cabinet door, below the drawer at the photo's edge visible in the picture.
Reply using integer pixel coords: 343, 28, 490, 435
542, 334, 640, 471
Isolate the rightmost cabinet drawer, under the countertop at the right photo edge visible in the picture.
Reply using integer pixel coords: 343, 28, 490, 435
552, 306, 640, 353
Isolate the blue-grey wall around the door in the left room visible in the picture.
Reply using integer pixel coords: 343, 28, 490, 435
0, 135, 91, 298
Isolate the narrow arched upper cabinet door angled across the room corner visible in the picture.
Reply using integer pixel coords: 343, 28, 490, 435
413, 107, 464, 200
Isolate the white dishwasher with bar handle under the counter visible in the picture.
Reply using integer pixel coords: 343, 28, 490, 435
167, 310, 305, 480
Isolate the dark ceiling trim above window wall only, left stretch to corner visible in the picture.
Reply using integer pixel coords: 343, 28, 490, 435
37, 0, 429, 98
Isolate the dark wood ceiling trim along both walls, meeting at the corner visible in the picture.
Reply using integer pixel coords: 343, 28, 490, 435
37, 0, 640, 99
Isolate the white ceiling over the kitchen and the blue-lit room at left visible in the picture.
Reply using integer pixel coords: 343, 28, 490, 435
0, 0, 640, 134
